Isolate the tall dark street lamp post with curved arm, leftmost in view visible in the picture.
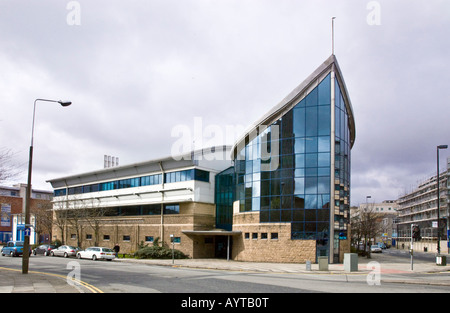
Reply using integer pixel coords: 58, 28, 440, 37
22, 99, 72, 274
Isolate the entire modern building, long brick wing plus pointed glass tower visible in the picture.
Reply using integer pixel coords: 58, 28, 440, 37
49, 55, 355, 263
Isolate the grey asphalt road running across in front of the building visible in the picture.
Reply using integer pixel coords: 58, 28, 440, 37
0, 252, 450, 295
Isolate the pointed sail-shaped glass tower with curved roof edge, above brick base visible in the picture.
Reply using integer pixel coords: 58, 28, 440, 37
229, 55, 355, 262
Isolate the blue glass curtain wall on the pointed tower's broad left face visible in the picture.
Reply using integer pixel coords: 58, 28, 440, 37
235, 75, 336, 255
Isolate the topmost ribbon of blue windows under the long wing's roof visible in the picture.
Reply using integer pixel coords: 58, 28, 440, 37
54, 169, 209, 197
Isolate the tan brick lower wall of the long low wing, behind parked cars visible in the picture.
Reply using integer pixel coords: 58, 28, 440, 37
53, 202, 215, 258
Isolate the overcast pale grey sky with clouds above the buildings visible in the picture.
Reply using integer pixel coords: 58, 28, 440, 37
0, 0, 450, 205
